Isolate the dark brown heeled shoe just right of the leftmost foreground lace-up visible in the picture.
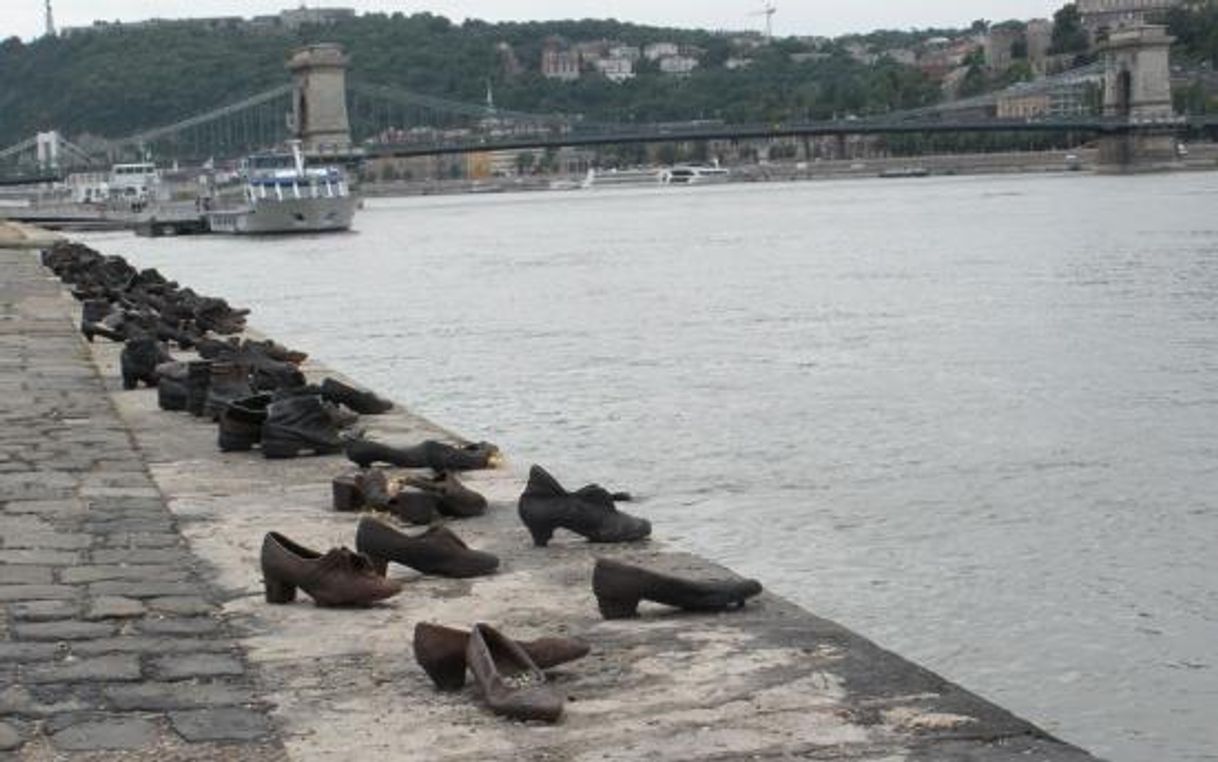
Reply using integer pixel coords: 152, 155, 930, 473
356, 519, 499, 578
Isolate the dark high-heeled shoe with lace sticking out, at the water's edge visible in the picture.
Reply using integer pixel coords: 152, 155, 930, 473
518, 465, 652, 548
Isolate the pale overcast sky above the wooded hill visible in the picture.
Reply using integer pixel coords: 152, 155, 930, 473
0, 0, 1066, 39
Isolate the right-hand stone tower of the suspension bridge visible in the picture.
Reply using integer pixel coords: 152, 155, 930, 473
1100, 26, 1177, 172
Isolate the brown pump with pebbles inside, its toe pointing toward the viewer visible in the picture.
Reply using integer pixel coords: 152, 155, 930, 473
465, 624, 563, 722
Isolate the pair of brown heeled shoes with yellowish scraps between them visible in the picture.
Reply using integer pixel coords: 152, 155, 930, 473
331, 469, 487, 525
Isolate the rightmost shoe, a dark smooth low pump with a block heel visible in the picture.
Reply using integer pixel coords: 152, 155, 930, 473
592, 559, 761, 620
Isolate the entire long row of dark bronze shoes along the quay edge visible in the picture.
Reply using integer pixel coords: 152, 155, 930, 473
43, 243, 761, 722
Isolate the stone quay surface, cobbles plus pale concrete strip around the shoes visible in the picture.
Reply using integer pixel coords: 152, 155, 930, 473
0, 245, 1093, 762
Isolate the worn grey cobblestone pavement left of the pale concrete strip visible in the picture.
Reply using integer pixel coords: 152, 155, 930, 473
0, 251, 285, 761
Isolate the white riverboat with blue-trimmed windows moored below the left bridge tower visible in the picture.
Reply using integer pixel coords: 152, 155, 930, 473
206, 142, 358, 235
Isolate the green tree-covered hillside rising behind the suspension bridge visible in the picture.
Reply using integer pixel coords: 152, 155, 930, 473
0, 13, 952, 146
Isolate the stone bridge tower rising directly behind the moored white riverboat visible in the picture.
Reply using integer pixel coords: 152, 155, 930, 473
287, 43, 351, 153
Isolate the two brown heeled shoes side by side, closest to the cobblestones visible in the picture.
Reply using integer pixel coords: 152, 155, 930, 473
261, 519, 499, 606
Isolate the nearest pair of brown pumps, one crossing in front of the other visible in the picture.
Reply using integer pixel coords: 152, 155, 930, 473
414, 622, 590, 722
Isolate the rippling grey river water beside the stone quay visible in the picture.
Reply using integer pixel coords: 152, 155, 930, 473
80, 174, 1218, 762
